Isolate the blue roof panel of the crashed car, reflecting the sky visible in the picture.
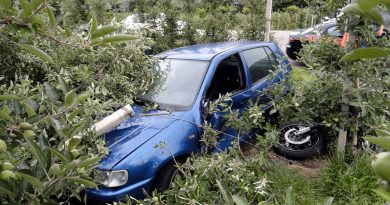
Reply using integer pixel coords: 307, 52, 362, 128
156, 41, 269, 60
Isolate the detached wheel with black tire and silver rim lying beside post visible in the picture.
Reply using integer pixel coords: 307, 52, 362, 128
274, 124, 326, 160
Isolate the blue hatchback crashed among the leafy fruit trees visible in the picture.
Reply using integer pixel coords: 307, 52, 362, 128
86, 41, 291, 204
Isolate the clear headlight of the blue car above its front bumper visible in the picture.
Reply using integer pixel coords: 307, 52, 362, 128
96, 170, 129, 188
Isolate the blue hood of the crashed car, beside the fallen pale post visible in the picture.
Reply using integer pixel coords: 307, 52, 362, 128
99, 105, 185, 170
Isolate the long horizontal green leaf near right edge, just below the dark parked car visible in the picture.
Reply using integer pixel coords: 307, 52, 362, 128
340, 47, 389, 62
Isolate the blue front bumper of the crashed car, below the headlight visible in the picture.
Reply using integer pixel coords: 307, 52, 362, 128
84, 177, 154, 205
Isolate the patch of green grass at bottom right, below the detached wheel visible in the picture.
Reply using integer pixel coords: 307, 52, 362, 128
266, 153, 384, 205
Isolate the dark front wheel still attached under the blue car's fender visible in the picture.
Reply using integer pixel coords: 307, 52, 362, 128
154, 162, 181, 192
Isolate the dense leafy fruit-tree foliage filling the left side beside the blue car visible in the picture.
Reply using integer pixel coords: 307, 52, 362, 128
0, 0, 156, 204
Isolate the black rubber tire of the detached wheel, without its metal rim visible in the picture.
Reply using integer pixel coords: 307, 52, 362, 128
274, 123, 326, 160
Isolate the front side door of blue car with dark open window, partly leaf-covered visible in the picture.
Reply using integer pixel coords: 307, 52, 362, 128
201, 53, 252, 151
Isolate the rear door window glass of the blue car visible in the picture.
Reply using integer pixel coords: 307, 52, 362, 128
242, 48, 273, 83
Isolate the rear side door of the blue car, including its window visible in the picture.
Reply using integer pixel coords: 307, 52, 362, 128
242, 46, 281, 105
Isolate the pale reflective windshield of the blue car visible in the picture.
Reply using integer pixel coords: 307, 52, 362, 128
139, 59, 209, 111
